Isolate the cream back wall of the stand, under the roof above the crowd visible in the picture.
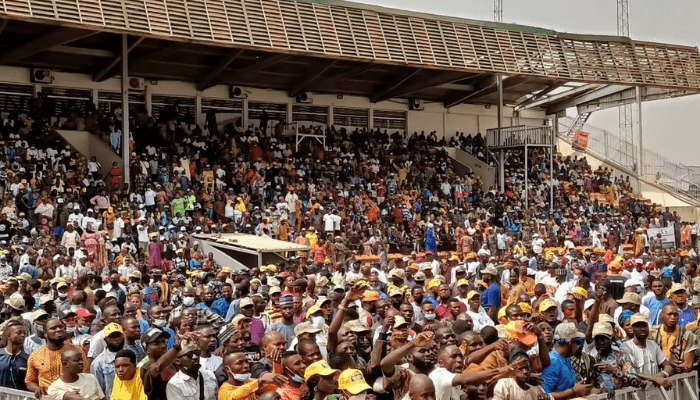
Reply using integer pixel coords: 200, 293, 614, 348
0, 66, 546, 138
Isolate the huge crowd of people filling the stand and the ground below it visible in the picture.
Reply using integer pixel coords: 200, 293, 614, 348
0, 100, 700, 400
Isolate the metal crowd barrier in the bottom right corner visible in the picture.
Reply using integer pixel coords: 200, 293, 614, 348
586, 371, 698, 400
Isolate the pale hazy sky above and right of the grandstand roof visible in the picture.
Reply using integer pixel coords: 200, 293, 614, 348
353, 0, 700, 166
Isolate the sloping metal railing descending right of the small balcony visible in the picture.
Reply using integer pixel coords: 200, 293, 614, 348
559, 116, 700, 199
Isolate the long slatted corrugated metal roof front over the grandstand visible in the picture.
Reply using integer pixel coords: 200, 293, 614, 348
0, 0, 700, 89
